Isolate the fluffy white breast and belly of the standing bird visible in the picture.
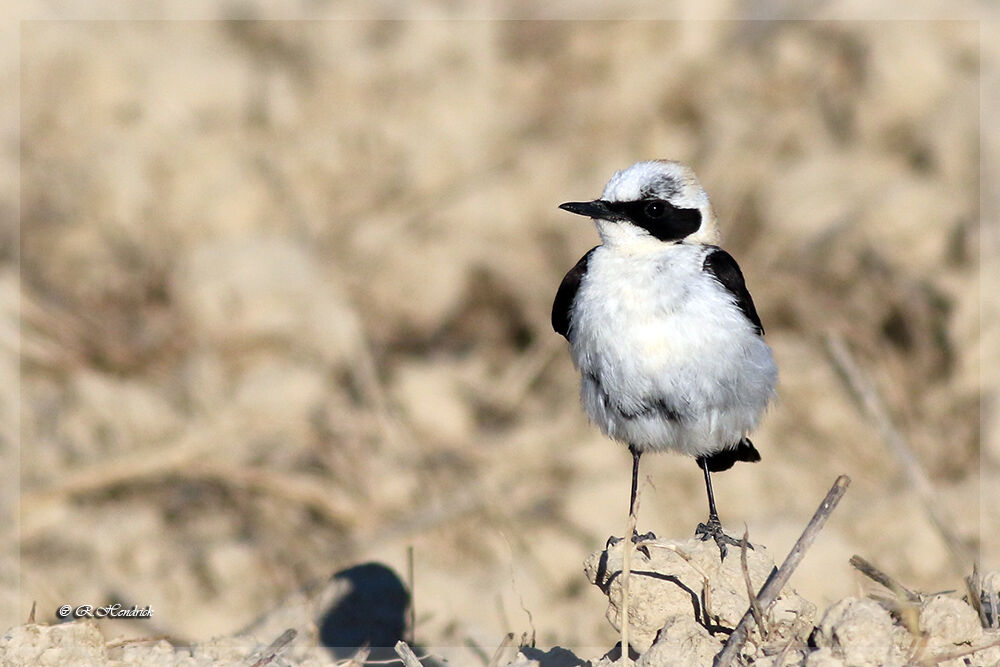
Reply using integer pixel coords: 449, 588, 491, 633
570, 244, 777, 456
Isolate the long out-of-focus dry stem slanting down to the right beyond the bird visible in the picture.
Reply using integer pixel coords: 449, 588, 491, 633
826, 332, 971, 577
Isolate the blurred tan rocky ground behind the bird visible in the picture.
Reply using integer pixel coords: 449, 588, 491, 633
0, 13, 1000, 657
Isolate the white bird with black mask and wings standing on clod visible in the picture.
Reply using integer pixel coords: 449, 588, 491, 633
552, 160, 778, 559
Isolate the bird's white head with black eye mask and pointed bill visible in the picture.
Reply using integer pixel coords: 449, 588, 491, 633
559, 160, 721, 249
